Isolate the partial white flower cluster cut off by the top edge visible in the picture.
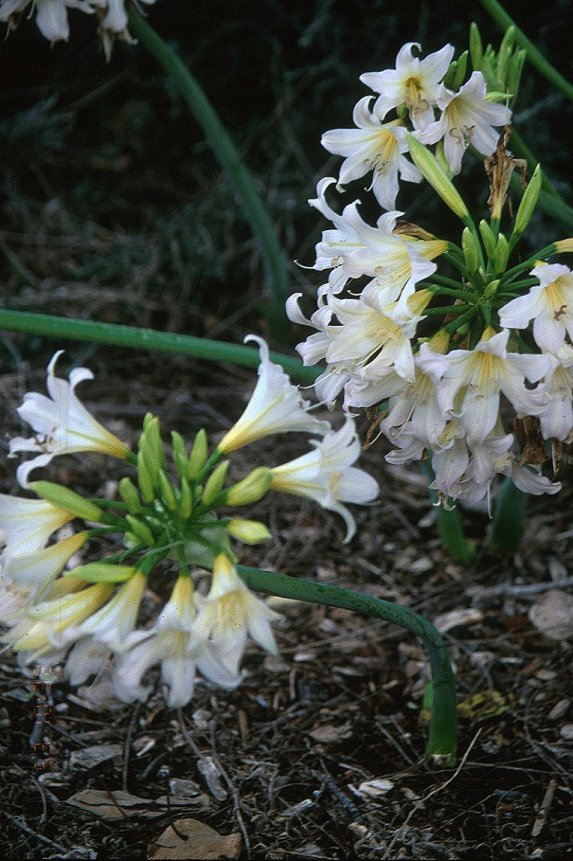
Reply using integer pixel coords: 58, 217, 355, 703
0, 0, 155, 60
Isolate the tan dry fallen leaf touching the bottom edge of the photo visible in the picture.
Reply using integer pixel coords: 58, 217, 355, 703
147, 819, 241, 861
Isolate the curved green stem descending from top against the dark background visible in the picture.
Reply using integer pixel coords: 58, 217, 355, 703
128, 10, 290, 341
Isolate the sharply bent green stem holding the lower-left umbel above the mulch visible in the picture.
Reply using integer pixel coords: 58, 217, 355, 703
237, 565, 457, 765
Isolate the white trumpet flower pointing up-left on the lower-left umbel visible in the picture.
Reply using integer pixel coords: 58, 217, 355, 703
10, 350, 129, 487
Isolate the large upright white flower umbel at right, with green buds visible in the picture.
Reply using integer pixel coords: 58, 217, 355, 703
287, 27, 573, 507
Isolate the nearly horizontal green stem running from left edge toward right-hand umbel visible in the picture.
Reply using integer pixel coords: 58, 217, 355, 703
0, 308, 320, 383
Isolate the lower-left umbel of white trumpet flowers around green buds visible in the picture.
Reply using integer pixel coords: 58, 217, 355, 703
0, 336, 378, 706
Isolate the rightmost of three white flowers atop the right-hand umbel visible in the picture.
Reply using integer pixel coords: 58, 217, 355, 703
419, 72, 511, 175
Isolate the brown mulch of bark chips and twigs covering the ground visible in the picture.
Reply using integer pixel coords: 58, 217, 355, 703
0, 352, 573, 859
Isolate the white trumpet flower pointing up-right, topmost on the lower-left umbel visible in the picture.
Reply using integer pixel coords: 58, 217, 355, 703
218, 335, 330, 454
